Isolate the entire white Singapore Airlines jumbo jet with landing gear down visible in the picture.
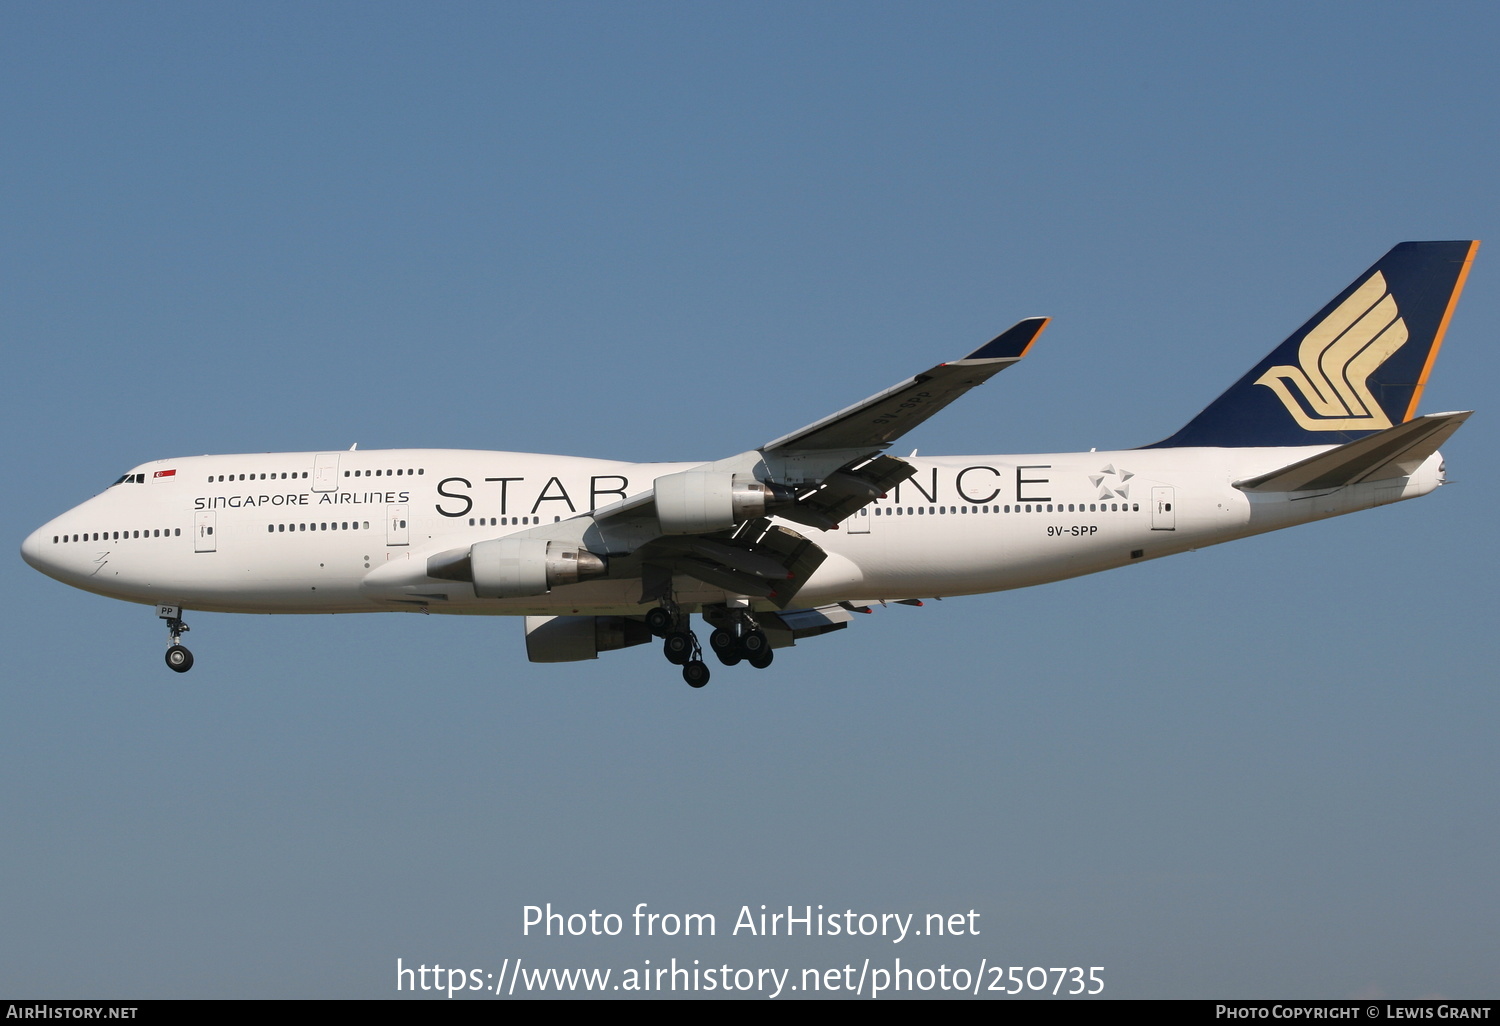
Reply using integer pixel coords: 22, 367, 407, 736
21, 242, 1479, 687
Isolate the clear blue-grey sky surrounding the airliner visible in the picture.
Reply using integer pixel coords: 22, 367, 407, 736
0, 3, 1500, 998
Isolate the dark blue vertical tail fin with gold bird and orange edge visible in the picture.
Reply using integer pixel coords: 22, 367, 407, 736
1148, 242, 1479, 449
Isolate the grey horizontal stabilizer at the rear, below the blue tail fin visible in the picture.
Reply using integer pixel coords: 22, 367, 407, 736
1235, 411, 1473, 492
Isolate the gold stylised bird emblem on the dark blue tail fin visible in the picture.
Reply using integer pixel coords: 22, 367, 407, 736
1256, 272, 1407, 431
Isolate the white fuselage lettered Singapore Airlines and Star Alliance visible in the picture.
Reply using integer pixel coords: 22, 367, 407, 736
14, 447, 1442, 615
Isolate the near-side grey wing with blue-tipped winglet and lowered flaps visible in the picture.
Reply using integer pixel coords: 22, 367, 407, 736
450, 317, 1047, 609
